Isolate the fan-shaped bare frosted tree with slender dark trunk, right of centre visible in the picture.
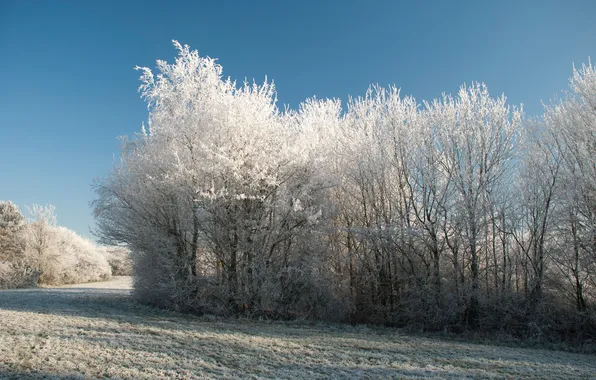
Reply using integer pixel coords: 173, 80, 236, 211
429, 84, 521, 326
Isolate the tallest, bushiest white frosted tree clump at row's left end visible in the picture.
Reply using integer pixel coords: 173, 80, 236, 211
95, 42, 338, 318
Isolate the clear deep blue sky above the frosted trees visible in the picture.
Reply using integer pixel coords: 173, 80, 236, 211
0, 0, 596, 236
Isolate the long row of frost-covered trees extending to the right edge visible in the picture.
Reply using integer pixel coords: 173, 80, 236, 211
94, 42, 596, 335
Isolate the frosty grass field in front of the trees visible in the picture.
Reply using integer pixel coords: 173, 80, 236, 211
0, 277, 596, 379
